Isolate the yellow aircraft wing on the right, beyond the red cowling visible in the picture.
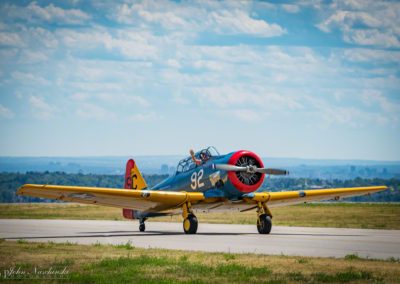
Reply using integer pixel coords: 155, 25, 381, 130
245, 186, 387, 207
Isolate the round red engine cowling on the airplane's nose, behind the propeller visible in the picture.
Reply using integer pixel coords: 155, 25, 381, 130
228, 151, 265, 193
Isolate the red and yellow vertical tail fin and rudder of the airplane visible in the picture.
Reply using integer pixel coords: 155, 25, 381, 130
122, 159, 147, 219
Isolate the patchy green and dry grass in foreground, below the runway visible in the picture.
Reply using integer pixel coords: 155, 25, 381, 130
0, 241, 400, 283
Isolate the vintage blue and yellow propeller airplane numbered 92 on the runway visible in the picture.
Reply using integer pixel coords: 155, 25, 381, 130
17, 146, 387, 234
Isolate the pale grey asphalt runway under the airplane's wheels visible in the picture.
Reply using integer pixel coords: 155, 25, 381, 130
0, 219, 400, 259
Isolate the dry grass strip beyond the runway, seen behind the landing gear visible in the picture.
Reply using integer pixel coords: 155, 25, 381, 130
0, 203, 400, 230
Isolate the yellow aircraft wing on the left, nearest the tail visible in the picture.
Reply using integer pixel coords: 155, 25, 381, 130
17, 184, 204, 212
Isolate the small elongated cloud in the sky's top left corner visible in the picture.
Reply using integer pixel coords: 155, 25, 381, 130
6, 1, 91, 25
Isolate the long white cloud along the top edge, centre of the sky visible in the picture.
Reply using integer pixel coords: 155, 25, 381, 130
111, 1, 286, 37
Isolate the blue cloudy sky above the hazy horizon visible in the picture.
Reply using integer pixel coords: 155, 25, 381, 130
0, 0, 400, 160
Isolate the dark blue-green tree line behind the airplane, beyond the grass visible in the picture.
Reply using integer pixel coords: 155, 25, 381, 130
0, 172, 400, 203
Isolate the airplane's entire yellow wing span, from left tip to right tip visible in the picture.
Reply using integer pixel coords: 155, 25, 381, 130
17, 184, 387, 212
